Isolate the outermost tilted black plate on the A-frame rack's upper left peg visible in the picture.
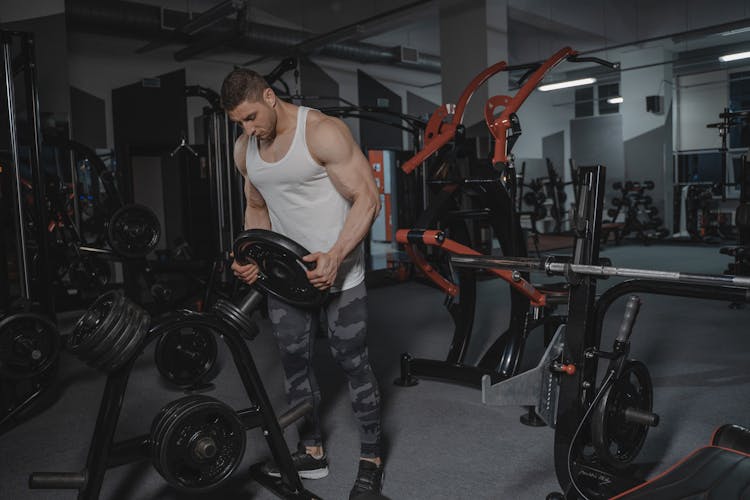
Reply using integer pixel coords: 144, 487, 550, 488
67, 291, 125, 358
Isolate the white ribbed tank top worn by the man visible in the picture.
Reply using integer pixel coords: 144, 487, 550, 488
245, 106, 365, 292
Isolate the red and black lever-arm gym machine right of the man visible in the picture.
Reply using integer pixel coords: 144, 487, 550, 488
395, 47, 617, 387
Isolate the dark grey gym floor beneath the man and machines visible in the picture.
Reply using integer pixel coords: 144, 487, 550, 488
0, 245, 750, 500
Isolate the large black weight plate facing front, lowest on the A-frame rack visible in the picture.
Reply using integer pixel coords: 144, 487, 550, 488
151, 395, 246, 493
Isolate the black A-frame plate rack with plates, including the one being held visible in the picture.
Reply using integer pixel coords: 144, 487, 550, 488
29, 229, 325, 500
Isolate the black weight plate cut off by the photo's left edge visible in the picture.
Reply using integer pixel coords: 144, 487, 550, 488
0, 313, 60, 380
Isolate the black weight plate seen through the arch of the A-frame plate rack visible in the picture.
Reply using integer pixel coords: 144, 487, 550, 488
154, 320, 218, 387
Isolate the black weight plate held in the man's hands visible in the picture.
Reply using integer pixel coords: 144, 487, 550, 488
234, 229, 327, 307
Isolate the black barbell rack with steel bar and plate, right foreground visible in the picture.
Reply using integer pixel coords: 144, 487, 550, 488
451, 166, 750, 500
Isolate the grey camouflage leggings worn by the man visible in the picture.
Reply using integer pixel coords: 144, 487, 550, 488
268, 283, 380, 458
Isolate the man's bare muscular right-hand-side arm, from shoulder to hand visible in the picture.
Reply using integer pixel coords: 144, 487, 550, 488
307, 116, 380, 287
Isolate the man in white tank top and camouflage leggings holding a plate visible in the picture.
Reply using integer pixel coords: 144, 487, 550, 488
221, 69, 383, 499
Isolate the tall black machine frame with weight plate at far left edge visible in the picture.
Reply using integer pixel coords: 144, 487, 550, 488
0, 30, 60, 432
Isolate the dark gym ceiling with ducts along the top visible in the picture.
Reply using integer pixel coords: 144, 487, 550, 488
66, 0, 750, 77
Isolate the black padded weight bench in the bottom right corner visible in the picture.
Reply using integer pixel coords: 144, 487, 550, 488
611, 424, 750, 500
